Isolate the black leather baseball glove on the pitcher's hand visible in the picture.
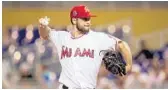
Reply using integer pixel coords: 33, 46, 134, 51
102, 50, 126, 76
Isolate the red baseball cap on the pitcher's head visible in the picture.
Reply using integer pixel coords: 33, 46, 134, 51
70, 5, 96, 18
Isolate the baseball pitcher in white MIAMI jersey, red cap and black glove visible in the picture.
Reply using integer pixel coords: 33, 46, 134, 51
39, 5, 132, 89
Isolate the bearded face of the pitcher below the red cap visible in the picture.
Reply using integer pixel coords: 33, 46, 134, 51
76, 18, 91, 33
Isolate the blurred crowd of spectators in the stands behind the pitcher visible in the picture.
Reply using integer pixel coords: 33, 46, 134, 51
2, 25, 168, 89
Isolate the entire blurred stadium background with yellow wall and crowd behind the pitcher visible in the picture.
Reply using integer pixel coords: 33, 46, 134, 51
2, 1, 168, 89
